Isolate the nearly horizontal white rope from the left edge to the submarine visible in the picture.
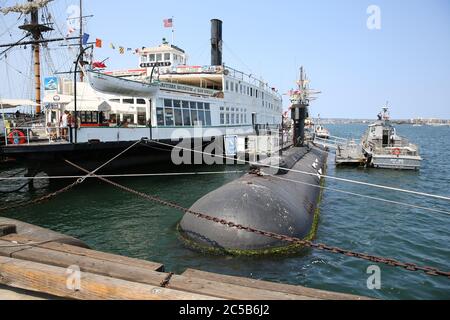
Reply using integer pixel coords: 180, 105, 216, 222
0, 170, 245, 181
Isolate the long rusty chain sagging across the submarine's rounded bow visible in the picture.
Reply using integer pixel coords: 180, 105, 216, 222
65, 160, 450, 279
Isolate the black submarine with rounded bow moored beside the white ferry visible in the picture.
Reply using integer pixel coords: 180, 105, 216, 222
179, 67, 328, 255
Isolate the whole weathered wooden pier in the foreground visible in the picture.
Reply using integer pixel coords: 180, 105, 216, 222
0, 225, 367, 300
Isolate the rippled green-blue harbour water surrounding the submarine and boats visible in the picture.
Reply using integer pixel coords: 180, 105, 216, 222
1, 125, 450, 299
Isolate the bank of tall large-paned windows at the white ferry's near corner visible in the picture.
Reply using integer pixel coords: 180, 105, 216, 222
156, 99, 211, 127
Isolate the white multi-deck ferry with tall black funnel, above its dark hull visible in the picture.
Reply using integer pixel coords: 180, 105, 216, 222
1, 19, 282, 172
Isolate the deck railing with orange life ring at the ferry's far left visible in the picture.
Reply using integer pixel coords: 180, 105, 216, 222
4, 126, 70, 146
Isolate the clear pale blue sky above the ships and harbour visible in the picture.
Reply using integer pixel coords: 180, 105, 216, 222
0, 0, 450, 118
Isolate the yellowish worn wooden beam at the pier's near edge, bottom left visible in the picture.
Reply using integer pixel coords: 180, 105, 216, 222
0, 257, 217, 300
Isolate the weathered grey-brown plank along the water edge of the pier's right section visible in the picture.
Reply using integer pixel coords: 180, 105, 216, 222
182, 269, 369, 300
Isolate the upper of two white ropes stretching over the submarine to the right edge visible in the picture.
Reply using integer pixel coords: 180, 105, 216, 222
152, 140, 450, 201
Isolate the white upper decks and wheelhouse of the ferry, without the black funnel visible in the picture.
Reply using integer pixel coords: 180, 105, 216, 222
81, 34, 282, 139
